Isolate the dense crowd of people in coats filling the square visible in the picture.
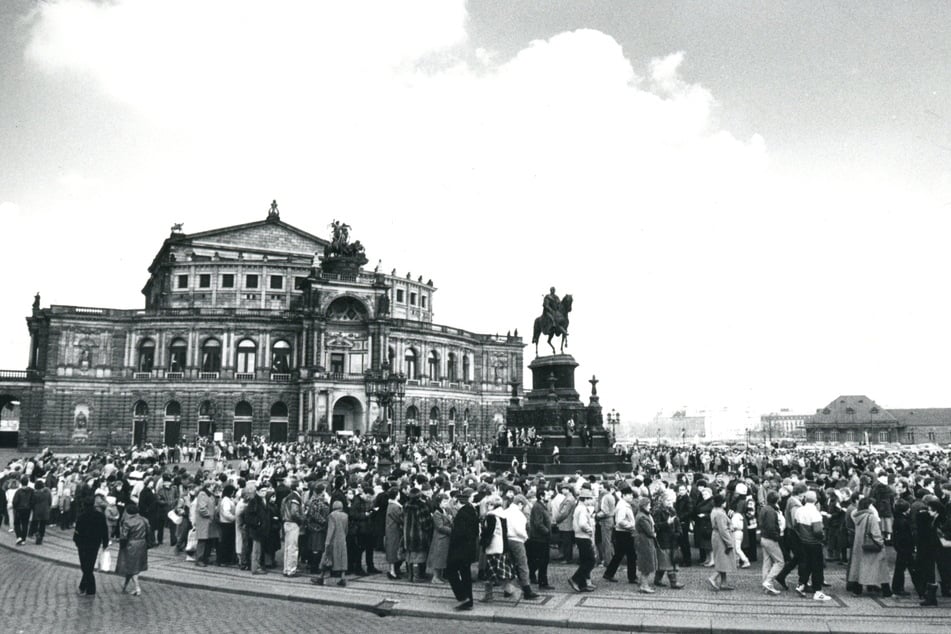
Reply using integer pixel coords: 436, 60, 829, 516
0, 437, 951, 610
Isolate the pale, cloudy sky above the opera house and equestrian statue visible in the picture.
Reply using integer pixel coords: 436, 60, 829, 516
0, 0, 951, 420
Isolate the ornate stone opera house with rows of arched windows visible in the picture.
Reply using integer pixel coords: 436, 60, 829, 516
0, 213, 524, 446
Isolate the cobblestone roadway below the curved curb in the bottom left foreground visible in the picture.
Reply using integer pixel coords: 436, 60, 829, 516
0, 551, 564, 634
